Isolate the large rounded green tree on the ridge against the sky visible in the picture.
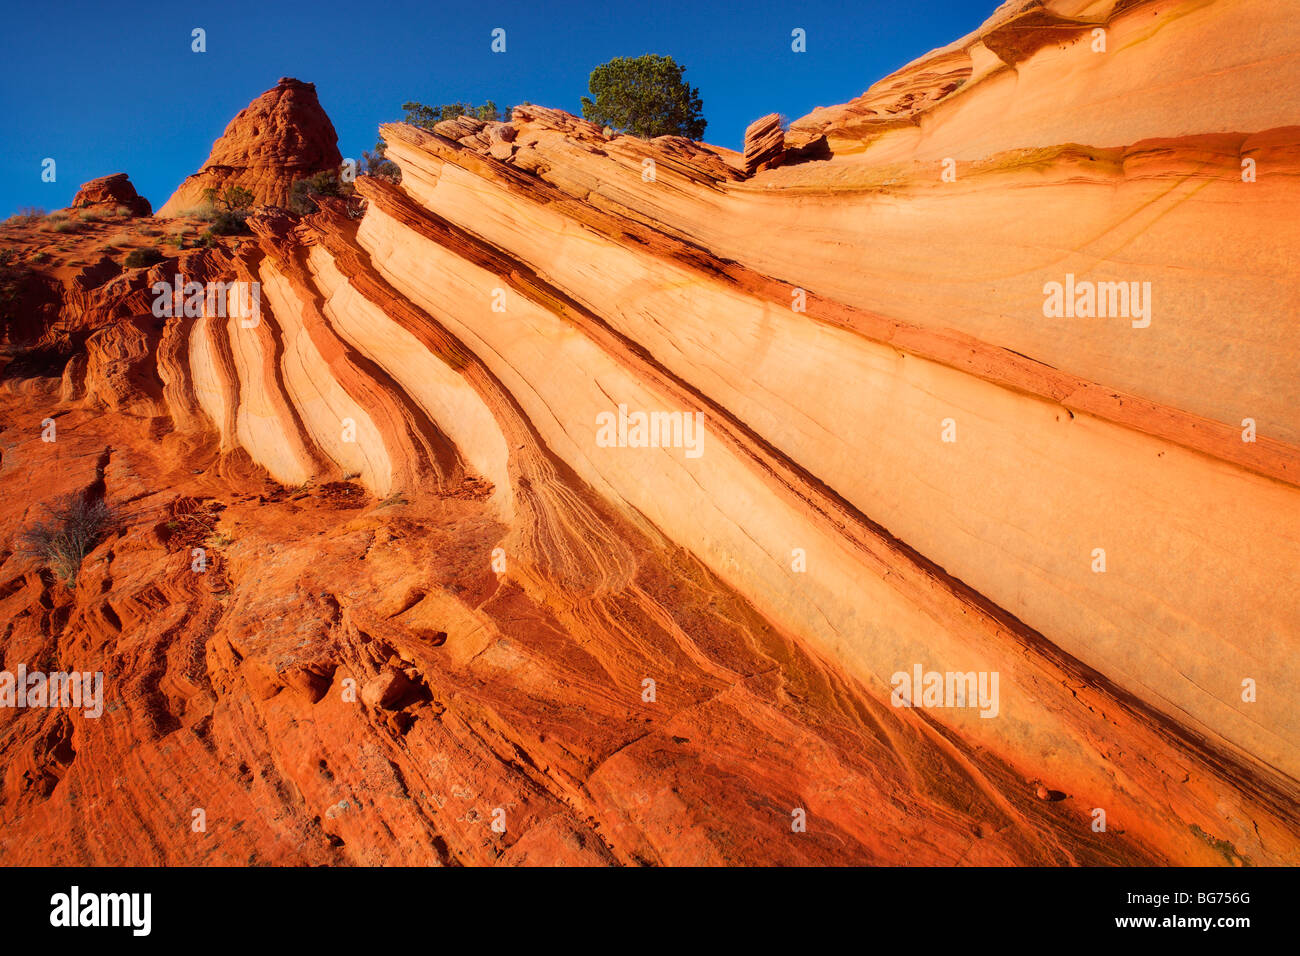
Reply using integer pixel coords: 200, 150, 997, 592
582, 53, 709, 139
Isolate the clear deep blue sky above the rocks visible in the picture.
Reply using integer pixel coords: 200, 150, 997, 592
0, 0, 998, 217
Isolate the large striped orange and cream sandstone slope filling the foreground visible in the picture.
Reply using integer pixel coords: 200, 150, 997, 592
0, 0, 1300, 865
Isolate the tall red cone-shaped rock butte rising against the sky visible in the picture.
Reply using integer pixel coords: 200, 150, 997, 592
159, 77, 343, 216
